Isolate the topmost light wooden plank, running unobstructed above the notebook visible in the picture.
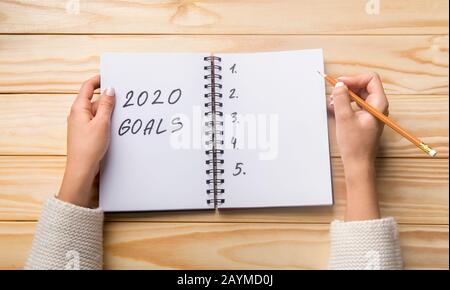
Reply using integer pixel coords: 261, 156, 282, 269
0, 0, 449, 34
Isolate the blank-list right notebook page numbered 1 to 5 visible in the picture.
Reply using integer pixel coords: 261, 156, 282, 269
218, 49, 333, 208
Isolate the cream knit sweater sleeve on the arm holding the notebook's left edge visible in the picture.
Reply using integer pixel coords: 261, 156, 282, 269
25, 197, 103, 270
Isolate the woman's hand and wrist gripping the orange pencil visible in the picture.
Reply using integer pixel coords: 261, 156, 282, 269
329, 73, 388, 220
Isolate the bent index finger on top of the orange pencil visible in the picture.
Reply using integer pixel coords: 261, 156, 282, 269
338, 72, 384, 98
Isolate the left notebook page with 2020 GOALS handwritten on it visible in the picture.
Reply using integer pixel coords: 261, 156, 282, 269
100, 53, 210, 211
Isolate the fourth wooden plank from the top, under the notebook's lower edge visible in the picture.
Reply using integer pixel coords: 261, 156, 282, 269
0, 156, 449, 224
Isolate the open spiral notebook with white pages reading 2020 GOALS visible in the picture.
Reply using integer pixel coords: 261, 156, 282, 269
100, 49, 333, 212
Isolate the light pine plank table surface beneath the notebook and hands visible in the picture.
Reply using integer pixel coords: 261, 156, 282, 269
0, 0, 449, 269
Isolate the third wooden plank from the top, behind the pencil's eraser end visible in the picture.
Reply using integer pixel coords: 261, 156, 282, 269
0, 94, 449, 158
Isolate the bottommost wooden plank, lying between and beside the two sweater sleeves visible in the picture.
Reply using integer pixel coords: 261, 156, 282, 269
0, 222, 449, 269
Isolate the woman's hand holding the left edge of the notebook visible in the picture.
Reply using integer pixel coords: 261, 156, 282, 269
58, 75, 115, 208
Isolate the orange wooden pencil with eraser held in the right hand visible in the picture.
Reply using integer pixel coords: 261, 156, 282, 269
317, 71, 437, 157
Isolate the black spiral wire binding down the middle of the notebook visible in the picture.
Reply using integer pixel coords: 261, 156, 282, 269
203, 56, 225, 207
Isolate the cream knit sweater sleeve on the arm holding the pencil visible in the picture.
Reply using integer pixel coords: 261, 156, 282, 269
329, 218, 403, 270
